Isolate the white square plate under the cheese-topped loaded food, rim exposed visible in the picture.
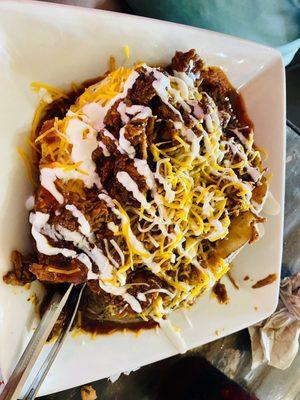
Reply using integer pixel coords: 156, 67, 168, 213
0, 1, 285, 394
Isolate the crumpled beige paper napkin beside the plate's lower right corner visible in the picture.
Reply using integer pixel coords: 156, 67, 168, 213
248, 273, 300, 369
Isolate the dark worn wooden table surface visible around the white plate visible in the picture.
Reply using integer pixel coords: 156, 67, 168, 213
33, 0, 300, 400
